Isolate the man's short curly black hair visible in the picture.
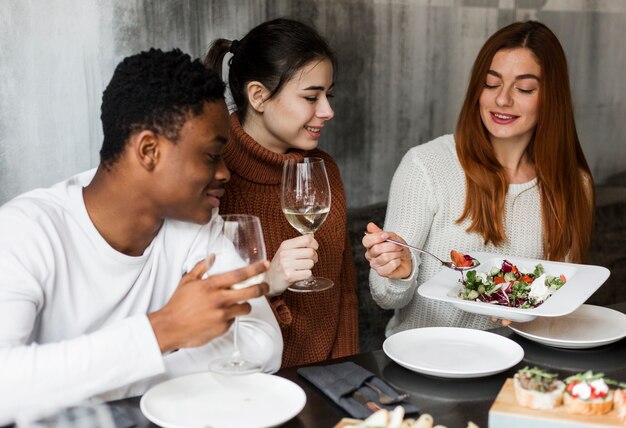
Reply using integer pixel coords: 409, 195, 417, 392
100, 49, 225, 165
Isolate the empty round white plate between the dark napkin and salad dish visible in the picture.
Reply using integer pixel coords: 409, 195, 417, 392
383, 327, 524, 378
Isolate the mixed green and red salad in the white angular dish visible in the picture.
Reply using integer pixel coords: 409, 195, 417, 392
459, 260, 567, 309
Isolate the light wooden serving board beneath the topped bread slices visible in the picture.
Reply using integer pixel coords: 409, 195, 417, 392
489, 379, 626, 428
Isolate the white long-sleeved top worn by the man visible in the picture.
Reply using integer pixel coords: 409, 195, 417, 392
0, 170, 282, 425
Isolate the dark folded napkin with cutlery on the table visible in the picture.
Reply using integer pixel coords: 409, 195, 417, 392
298, 362, 418, 419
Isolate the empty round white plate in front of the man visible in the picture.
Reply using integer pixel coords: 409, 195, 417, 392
140, 372, 306, 428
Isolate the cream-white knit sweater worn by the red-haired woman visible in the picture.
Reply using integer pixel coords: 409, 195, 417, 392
370, 135, 543, 336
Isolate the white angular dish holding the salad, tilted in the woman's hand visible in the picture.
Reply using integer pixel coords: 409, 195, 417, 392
418, 253, 610, 322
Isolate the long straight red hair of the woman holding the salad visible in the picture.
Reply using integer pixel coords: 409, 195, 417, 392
455, 21, 595, 262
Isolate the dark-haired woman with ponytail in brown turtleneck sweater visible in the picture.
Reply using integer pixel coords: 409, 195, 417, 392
205, 18, 358, 367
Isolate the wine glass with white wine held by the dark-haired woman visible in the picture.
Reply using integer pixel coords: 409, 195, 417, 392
280, 158, 334, 292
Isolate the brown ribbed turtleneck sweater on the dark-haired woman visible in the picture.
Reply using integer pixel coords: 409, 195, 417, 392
220, 113, 359, 367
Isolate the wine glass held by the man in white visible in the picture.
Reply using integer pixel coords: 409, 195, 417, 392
208, 214, 267, 375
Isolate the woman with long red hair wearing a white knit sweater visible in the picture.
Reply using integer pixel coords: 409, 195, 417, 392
363, 21, 594, 335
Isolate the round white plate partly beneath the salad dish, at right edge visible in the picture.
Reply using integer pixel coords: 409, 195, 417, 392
509, 305, 626, 349
